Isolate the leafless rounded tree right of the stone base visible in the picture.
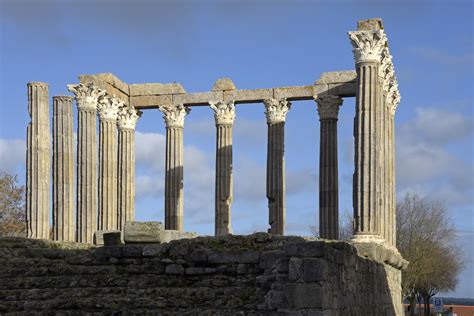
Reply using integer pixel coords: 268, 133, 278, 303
397, 194, 463, 315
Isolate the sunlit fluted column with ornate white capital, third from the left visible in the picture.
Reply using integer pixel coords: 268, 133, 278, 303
68, 83, 105, 243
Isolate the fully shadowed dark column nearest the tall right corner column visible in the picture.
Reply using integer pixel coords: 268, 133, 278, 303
316, 95, 342, 239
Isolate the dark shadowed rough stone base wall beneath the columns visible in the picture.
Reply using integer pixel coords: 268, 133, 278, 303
0, 233, 401, 315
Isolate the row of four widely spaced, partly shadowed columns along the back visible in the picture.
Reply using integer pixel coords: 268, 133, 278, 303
159, 95, 342, 239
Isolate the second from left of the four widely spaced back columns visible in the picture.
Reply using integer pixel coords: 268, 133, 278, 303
210, 102, 235, 236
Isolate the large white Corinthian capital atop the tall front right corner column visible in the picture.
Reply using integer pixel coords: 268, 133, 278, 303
348, 30, 387, 63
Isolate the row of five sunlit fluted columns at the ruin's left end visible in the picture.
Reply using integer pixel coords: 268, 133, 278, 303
26, 82, 140, 243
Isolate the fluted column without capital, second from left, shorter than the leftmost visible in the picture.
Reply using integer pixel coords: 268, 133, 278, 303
53, 96, 74, 241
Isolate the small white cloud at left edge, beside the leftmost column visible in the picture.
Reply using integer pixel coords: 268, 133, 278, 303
0, 139, 26, 173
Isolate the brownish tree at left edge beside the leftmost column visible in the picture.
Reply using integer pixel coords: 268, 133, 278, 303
0, 172, 26, 237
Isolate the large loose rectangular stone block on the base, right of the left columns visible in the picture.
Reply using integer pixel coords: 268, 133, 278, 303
123, 222, 164, 244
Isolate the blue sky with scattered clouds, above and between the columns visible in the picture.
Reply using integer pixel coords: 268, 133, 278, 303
0, 0, 474, 297
